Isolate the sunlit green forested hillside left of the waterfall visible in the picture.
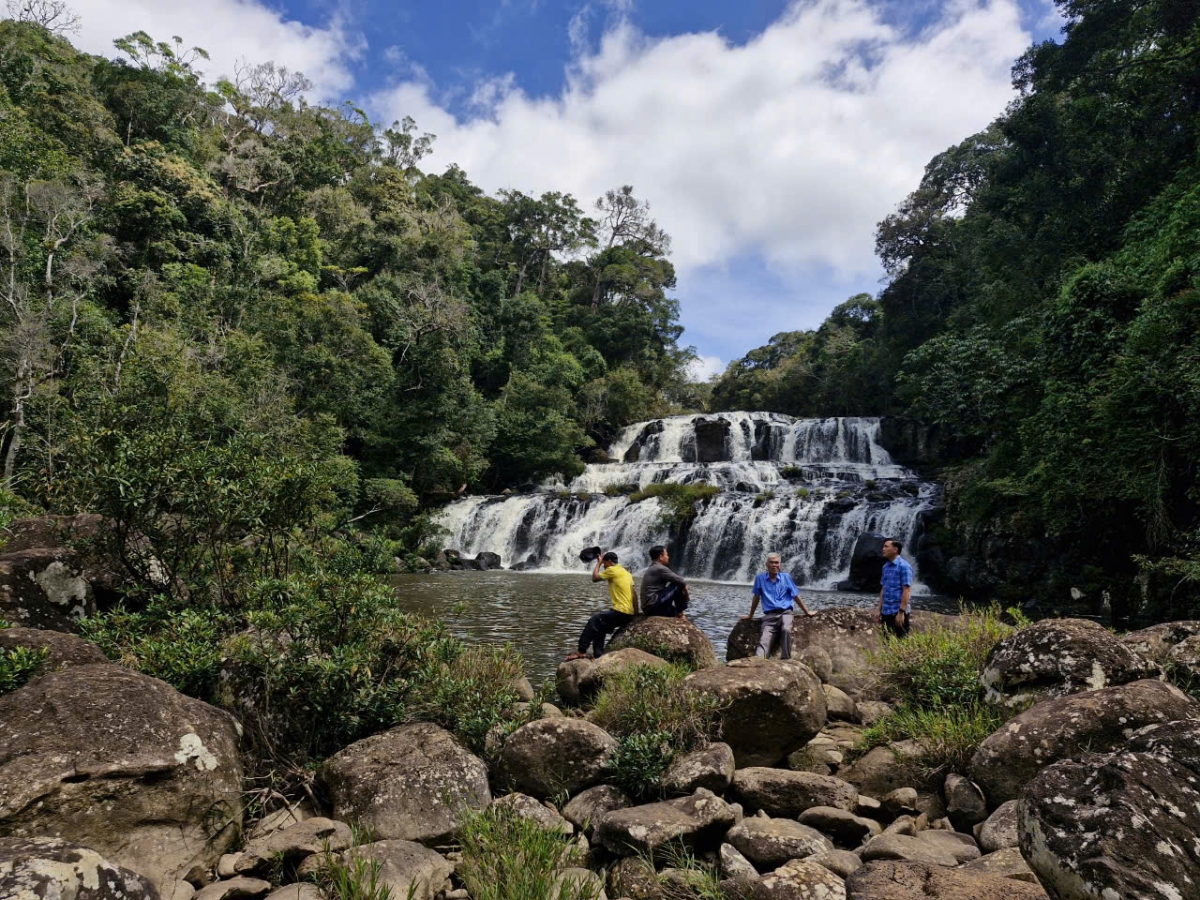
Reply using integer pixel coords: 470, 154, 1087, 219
0, 20, 692, 556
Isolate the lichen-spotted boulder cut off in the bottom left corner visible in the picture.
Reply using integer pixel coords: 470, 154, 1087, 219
0, 838, 160, 900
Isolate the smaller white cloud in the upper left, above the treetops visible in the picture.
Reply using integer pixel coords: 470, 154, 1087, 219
70, 0, 364, 101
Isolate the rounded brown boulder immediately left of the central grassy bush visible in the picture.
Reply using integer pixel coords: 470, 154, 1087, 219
499, 719, 617, 799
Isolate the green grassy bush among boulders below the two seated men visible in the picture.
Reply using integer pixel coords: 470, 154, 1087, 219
592, 664, 720, 798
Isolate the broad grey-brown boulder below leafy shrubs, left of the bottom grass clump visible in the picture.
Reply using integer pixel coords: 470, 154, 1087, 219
320, 722, 492, 844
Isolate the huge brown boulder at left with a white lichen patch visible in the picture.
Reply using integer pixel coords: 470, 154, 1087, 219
0, 664, 242, 896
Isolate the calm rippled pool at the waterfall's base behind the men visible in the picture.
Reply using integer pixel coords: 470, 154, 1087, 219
392, 571, 956, 683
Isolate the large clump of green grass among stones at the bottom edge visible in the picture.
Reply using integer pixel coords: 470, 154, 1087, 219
458, 806, 599, 900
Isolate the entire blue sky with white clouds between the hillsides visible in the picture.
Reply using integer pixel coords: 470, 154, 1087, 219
56, 0, 1061, 373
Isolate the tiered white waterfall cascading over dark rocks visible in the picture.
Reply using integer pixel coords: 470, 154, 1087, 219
440, 413, 940, 588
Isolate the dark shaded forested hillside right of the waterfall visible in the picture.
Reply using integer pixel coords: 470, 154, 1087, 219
714, 0, 1200, 614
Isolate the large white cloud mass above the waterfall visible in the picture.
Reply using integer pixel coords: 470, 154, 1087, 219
372, 0, 1030, 280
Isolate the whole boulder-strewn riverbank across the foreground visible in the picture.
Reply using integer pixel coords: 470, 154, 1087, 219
0, 518, 1200, 900
